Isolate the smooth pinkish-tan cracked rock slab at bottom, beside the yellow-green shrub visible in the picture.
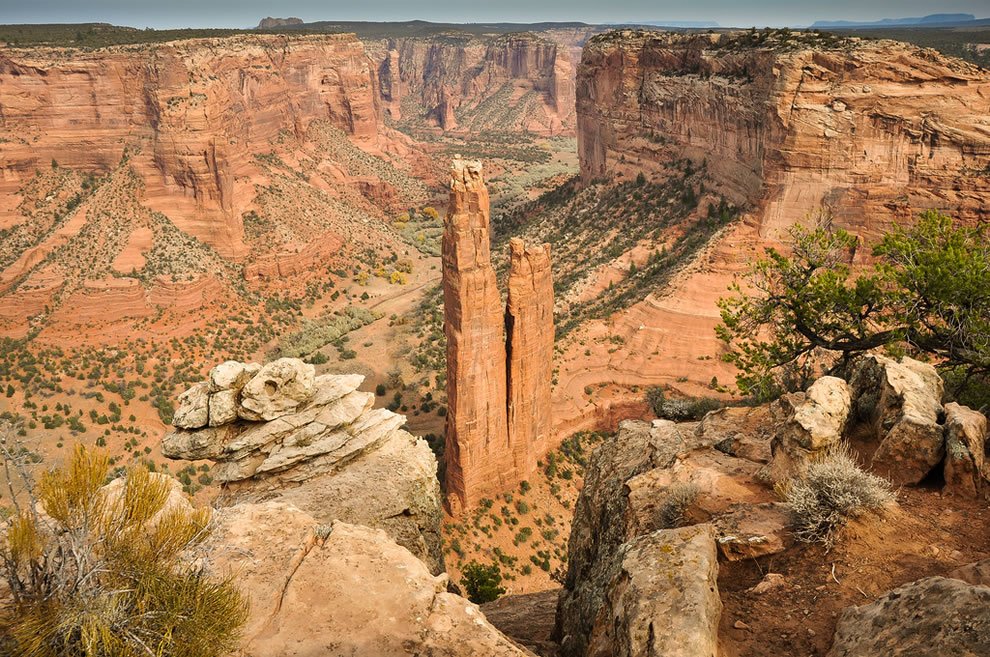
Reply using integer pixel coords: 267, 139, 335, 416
201, 504, 531, 657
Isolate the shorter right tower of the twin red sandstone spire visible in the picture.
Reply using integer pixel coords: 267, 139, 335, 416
505, 238, 554, 474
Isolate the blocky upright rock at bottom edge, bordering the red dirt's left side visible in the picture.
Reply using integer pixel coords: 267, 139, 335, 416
576, 525, 722, 657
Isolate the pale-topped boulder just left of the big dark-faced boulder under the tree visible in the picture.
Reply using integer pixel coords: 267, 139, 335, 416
770, 376, 852, 482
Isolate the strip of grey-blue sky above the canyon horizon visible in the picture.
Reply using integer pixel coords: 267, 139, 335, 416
0, 0, 990, 29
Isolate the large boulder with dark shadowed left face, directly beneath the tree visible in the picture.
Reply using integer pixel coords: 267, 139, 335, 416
849, 354, 945, 485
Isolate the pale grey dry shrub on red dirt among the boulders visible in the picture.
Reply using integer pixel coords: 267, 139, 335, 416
781, 448, 894, 547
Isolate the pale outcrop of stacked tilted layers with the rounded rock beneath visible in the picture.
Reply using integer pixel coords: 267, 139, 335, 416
162, 358, 443, 573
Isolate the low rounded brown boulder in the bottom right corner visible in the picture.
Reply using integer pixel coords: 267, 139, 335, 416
827, 577, 990, 657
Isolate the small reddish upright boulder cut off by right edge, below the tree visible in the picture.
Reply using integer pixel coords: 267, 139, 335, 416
944, 402, 990, 497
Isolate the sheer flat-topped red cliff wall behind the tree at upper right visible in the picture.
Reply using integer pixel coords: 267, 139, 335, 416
577, 31, 990, 238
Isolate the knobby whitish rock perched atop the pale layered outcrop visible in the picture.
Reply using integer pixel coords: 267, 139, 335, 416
238, 358, 316, 420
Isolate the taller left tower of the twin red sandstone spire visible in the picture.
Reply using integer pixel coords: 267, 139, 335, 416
443, 158, 513, 507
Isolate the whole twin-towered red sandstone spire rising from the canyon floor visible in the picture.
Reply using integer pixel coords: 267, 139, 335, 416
443, 158, 553, 507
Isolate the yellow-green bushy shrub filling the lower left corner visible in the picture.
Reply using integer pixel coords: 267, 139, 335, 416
0, 446, 247, 657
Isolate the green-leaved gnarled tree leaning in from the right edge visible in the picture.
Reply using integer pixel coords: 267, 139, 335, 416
716, 211, 990, 401
